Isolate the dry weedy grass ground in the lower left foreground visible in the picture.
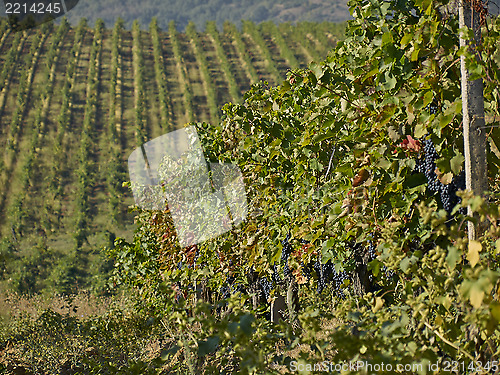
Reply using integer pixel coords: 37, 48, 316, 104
0, 292, 337, 374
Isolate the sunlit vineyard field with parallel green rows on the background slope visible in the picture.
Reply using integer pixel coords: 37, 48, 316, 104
0, 17, 343, 291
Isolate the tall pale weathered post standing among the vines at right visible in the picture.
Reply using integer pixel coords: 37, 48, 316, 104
458, 0, 488, 240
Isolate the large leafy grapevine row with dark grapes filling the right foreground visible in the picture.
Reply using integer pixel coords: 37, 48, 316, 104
110, 0, 500, 372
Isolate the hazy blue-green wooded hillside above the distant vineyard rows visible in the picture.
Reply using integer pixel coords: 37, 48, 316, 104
61, 0, 351, 30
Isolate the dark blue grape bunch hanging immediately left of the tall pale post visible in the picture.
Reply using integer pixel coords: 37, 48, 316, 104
415, 139, 465, 214
